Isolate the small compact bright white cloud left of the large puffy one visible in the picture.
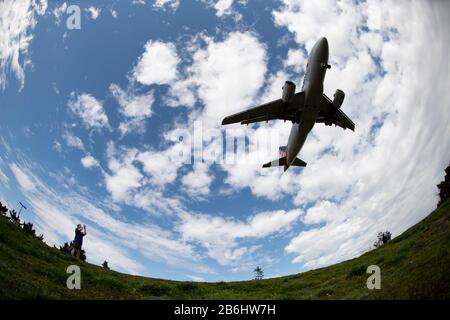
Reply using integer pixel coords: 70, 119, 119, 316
133, 40, 179, 85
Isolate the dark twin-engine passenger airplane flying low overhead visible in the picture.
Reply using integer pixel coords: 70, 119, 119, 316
222, 37, 355, 171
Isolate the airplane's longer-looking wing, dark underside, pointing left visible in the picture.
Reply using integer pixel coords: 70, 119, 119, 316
222, 92, 305, 125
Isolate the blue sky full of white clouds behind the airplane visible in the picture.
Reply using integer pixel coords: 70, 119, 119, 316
0, 0, 450, 281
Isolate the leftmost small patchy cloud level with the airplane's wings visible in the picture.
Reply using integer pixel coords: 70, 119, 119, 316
68, 92, 109, 129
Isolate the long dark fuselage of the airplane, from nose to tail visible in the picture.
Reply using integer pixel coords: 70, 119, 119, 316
284, 38, 328, 171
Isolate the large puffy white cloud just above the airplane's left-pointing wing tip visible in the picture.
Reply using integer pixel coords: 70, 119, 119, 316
182, 32, 266, 128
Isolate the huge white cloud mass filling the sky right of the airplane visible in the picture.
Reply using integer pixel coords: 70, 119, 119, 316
273, 1, 450, 269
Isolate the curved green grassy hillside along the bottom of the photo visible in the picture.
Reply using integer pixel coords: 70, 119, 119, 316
0, 201, 450, 299
